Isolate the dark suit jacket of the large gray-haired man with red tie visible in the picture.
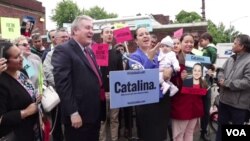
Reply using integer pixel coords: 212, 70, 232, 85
52, 39, 100, 124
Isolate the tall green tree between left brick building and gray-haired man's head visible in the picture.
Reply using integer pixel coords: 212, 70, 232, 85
51, 0, 82, 27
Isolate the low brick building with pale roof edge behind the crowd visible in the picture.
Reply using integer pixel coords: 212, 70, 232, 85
94, 14, 208, 52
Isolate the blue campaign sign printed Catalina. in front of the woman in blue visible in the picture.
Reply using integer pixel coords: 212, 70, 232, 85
109, 69, 160, 109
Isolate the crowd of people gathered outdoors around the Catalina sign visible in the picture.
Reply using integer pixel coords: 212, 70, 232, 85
0, 15, 250, 141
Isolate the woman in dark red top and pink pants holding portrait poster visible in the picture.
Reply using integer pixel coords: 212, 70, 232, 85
171, 34, 206, 141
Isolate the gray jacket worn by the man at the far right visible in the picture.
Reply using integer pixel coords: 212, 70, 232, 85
220, 53, 250, 110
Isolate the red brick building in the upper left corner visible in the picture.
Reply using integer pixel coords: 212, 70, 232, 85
0, 0, 46, 34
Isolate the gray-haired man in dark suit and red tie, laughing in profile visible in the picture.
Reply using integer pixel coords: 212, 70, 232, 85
52, 15, 103, 141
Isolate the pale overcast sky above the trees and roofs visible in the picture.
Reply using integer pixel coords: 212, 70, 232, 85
38, 0, 250, 35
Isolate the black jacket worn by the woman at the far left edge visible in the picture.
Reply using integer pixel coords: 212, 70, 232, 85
0, 72, 39, 141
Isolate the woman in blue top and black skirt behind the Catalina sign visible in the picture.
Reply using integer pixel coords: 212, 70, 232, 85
129, 27, 173, 141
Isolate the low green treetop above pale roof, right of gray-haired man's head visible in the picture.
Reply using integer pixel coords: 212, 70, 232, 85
84, 6, 118, 20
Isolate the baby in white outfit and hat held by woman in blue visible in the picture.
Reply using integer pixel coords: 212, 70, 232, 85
158, 36, 180, 96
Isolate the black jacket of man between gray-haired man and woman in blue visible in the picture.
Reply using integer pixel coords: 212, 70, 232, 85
101, 49, 123, 92
